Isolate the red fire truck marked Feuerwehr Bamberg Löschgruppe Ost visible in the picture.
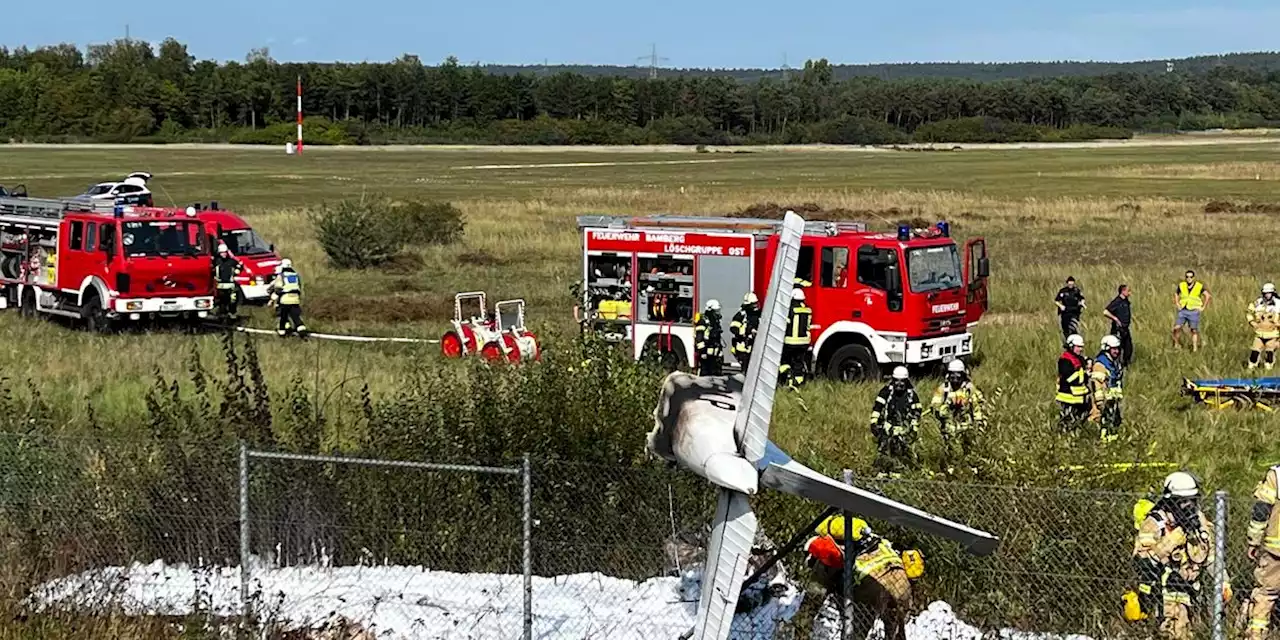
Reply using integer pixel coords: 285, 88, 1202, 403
577, 215, 989, 380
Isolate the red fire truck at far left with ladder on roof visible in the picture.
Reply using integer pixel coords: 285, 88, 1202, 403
0, 197, 214, 332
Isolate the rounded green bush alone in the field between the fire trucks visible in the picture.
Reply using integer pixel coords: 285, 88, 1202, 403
310, 195, 465, 269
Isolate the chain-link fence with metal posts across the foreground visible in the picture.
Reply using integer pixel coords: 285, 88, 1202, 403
0, 434, 1252, 640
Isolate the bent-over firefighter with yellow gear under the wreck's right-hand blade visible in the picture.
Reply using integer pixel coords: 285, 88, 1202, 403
804, 516, 923, 640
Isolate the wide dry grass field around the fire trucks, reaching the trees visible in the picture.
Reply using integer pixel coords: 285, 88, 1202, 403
0, 141, 1280, 492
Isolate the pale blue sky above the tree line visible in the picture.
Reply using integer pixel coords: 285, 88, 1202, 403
0, 0, 1280, 68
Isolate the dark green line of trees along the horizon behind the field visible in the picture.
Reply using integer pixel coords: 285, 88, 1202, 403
0, 38, 1280, 145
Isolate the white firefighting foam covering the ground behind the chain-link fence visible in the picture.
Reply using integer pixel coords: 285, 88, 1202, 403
29, 561, 1092, 640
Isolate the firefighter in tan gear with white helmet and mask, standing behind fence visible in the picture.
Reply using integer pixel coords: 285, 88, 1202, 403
1133, 471, 1213, 640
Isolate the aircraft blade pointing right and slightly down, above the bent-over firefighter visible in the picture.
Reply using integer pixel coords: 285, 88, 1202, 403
760, 455, 1000, 556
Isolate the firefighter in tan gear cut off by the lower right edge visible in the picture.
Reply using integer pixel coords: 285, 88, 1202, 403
1244, 466, 1280, 640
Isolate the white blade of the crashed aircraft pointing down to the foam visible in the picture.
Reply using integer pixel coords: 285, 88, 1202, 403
691, 489, 756, 640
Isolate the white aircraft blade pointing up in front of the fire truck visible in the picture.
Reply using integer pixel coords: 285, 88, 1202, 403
733, 211, 804, 465
